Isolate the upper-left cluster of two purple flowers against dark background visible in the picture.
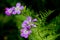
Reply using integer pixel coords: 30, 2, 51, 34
5, 3, 24, 16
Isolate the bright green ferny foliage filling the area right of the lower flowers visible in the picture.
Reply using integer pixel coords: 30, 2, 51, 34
29, 10, 60, 40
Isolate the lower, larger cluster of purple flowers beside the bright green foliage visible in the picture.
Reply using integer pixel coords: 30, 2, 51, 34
21, 16, 37, 38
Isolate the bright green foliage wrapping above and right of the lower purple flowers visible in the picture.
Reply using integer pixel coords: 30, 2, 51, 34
14, 7, 60, 40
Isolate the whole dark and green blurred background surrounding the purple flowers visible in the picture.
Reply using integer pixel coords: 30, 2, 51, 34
0, 0, 60, 40
